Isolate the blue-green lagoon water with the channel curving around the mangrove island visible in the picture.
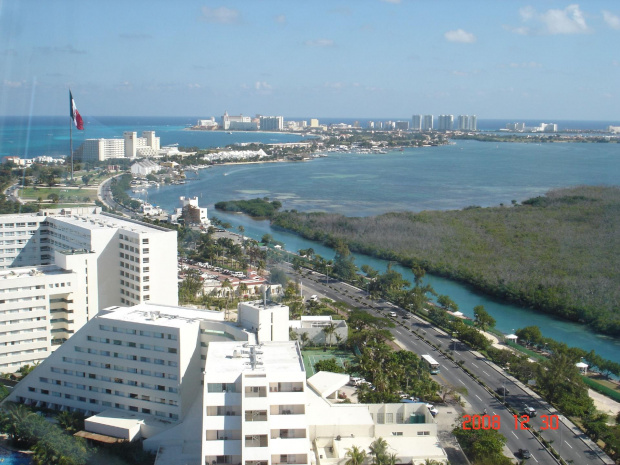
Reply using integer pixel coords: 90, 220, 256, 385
139, 141, 620, 360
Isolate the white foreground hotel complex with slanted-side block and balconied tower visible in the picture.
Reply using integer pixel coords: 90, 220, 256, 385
7, 302, 447, 465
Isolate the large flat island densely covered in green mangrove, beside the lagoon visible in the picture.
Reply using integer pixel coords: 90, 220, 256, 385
271, 186, 620, 336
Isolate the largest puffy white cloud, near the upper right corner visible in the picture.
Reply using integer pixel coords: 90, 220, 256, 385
507, 4, 590, 35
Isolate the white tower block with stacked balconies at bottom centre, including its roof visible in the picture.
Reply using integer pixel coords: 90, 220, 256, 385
201, 342, 310, 465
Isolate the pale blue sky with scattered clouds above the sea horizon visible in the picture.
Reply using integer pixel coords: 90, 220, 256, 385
0, 0, 620, 121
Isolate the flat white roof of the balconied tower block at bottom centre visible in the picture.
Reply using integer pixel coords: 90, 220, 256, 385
205, 342, 305, 377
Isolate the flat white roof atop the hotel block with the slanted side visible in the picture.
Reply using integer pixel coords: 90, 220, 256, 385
98, 303, 224, 328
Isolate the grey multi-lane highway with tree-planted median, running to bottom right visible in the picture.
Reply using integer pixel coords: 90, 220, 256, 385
288, 267, 613, 465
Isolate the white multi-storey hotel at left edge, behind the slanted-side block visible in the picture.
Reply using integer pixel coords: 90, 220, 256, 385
0, 208, 178, 372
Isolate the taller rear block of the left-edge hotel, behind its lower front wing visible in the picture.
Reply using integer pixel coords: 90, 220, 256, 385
0, 208, 178, 312
